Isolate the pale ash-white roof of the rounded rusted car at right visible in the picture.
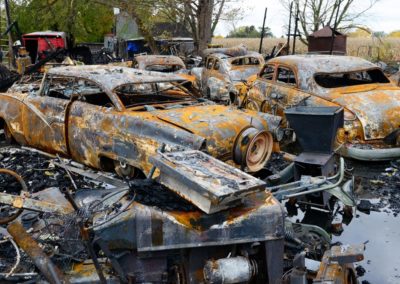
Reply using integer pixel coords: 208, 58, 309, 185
267, 54, 378, 74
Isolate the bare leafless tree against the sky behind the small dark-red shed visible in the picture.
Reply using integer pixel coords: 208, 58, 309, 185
284, 0, 379, 44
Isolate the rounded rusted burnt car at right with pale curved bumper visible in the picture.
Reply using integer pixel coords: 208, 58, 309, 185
240, 55, 400, 160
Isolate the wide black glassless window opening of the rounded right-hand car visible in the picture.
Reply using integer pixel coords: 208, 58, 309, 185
314, 69, 389, 88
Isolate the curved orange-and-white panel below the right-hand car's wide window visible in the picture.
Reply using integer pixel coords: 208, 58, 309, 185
332, 88, 400, 140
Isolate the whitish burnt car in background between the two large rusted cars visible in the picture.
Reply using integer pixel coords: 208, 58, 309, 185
192, 47, 264, 103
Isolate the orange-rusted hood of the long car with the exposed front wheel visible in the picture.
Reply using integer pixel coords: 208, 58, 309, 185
153, 105, 268, 158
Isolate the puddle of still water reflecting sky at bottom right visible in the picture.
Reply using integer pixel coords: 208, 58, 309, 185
290, 196, 400, 284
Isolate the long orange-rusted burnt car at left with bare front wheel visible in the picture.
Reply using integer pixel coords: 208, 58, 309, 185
0, 66, 273, 177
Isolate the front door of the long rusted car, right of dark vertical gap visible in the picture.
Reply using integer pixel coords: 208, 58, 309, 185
67, 79, 116, 167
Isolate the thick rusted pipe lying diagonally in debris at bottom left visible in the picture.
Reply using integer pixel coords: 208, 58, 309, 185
7, 222, 68, 284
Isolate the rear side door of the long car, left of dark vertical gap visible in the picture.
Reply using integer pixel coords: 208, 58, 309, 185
23, 75, 72, 155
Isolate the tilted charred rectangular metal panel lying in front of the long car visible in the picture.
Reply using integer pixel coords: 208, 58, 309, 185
150, 151, 266, 214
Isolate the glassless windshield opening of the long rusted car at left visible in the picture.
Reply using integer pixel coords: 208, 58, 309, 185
115, 81, 193, 108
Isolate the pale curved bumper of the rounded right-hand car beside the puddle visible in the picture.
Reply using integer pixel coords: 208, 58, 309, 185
337, 144, 400, 161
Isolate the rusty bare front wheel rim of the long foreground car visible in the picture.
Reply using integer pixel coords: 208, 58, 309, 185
246, 131, 273, 172
